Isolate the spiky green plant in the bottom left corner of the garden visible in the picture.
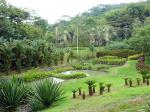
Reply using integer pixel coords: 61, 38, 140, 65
0, 77, 30, 111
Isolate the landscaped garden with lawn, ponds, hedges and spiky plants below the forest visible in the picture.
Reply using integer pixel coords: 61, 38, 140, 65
0, 47, 149, 112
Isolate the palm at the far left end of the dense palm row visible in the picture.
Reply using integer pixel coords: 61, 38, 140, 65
0, 43, 12, 75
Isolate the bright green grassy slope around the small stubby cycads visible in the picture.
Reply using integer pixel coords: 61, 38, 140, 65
44, 61, 150, 112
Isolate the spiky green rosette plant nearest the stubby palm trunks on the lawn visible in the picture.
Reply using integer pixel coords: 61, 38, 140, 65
32, 79, 64, 108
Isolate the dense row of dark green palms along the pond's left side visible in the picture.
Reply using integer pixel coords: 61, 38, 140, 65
0, 40, 68, 74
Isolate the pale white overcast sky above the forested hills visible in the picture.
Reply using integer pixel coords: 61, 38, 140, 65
7, 0, 142, 24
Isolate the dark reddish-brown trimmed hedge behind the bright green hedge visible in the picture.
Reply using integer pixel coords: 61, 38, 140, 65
96, 49, 139, 58
